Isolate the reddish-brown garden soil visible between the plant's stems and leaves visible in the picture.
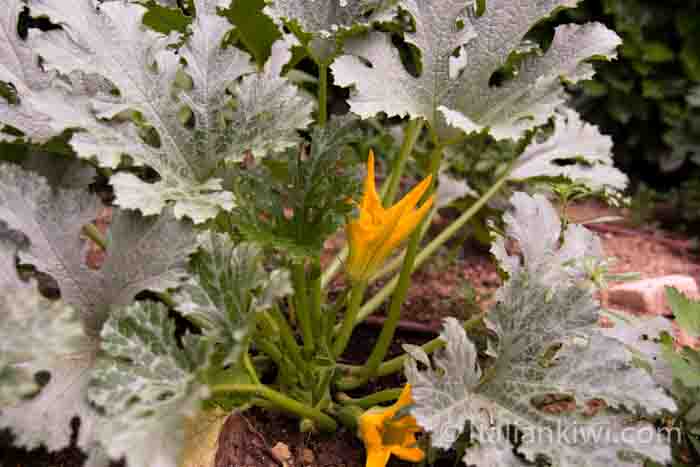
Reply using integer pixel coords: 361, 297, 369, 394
0, 203, 700, 467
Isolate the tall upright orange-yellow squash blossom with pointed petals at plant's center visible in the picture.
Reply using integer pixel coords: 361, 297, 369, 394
346, 150, 433, 281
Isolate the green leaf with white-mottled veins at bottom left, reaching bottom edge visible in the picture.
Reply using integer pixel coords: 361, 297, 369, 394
88, 302, 208, 467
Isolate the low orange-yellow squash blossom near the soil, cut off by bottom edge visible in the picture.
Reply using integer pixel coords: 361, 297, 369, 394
359, 384, 425, 467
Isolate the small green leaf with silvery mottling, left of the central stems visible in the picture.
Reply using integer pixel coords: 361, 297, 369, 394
175, 233, 292, 365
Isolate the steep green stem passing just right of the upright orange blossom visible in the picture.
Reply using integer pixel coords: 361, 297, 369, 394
350, 146, 442, 388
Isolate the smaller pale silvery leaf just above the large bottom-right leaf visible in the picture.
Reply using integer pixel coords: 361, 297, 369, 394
491, 192, 603, 288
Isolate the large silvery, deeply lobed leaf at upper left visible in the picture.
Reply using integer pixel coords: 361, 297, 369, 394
31, 0, 311, 223
